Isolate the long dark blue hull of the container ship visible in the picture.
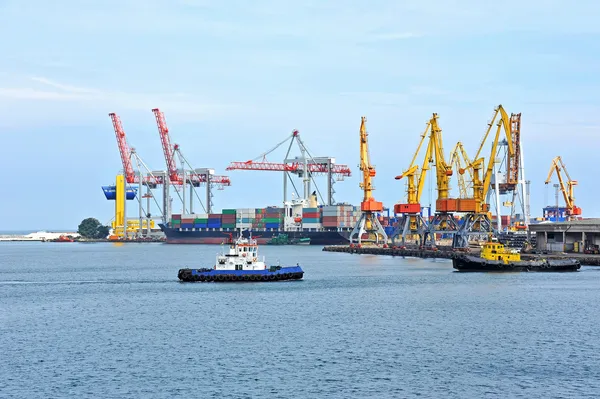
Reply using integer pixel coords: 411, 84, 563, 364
159, 223, 350, 246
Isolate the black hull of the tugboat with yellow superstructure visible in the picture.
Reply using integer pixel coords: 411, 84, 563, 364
452, 255, 581, 272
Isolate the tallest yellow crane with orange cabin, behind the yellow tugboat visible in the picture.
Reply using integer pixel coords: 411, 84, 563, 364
453, 105, 520, 248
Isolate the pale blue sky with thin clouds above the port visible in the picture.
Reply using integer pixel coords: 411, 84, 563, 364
0, 0, 600, 230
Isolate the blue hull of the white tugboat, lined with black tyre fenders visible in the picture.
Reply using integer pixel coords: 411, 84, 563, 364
177, 266, 304, 283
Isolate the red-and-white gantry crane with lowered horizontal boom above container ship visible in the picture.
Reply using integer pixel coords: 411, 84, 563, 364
227, 130, 351, 205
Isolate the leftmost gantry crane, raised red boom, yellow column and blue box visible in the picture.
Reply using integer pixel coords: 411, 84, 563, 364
102, 112, 164, 238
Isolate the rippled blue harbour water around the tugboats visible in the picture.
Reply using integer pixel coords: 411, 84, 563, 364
0, 243, 600, 398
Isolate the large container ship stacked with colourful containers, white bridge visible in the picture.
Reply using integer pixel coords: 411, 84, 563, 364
159, 195, 394, 245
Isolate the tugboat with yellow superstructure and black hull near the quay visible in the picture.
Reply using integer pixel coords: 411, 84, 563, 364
452, 237, 581, 272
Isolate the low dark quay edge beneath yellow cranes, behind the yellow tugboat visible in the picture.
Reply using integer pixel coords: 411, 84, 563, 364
323, 245, 600, 266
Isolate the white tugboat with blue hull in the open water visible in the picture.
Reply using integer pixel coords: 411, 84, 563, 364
177, 234, 304, 282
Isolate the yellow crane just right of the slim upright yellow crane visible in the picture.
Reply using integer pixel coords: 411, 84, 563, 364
391, 121, 435, 247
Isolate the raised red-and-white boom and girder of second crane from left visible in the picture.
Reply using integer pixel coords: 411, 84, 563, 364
152, 108, 231, 187
